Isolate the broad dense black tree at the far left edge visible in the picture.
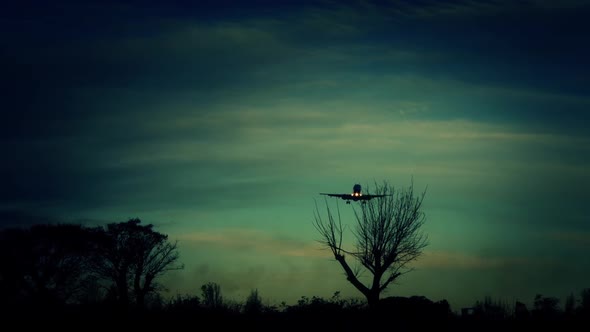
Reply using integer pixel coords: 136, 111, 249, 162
0, 224, 92, 309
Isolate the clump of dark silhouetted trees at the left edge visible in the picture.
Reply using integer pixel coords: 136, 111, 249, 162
0, 219, 182, 314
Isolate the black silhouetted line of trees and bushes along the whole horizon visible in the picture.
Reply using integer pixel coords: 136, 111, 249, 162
0, 219, 590, 329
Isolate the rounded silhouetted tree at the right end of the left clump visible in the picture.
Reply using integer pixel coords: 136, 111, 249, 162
93, 218, 183, 308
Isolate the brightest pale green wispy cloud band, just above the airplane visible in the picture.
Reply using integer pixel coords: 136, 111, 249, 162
118, 110, 589, 168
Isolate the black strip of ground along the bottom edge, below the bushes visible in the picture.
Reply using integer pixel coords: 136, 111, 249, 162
0, 308, 590, 332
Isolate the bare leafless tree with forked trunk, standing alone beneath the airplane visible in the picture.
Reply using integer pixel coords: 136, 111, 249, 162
314, 182, 428, 307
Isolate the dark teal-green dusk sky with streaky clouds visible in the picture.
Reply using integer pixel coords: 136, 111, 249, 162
0, 0, 590, 310
